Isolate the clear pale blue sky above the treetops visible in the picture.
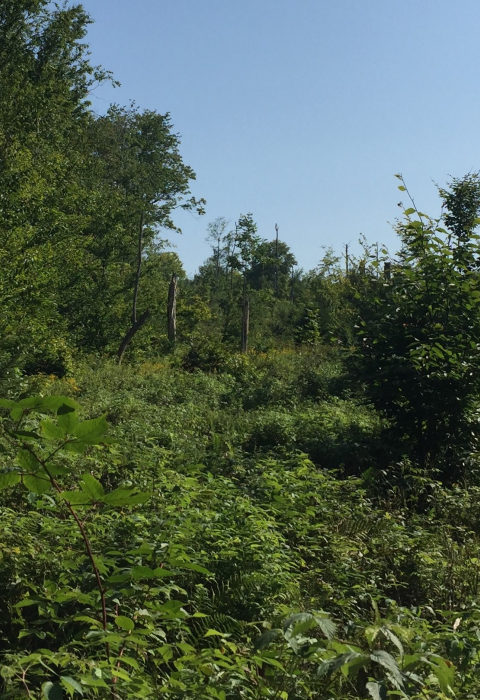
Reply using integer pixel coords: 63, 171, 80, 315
79, 0, 480, 273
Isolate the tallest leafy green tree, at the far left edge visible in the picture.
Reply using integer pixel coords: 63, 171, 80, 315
0, 0, 109, 371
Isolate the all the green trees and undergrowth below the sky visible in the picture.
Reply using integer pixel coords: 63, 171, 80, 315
0, 0, 480, 700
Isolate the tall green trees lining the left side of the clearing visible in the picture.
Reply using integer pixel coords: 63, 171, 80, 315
0, 0, 203, 372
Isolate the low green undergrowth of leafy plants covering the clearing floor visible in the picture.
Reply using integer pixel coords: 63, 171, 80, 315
0, 353, 480, 700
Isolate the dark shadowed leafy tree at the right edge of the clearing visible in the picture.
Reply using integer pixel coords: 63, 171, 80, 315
352, 176, 480, 477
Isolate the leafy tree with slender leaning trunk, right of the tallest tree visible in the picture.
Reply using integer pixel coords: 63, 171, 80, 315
58, 105, 204, 357
